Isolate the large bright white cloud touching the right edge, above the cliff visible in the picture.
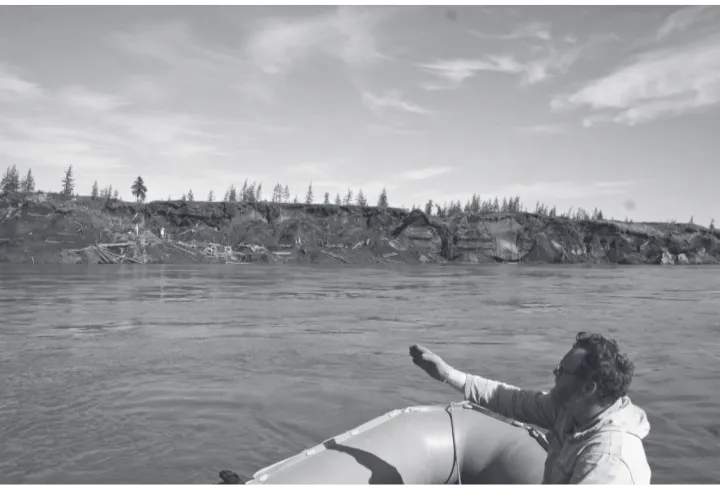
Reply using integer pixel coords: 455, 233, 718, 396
551, 33, 720, 126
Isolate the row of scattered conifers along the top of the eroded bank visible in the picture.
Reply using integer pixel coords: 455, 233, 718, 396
0, 165, 715, 230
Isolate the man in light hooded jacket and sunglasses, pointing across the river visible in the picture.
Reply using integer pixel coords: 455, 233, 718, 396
410, 332, 651, 484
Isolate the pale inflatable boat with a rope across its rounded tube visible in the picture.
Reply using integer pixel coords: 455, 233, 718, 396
246, 402, 546, 484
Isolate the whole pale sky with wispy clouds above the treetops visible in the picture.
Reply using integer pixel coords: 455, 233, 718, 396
0, 5, 720, 225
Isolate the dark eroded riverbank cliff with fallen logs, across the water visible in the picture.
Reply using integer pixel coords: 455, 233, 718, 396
0, 194, 720, 264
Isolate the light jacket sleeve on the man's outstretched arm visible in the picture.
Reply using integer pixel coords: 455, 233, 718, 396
464, 374, 559, 430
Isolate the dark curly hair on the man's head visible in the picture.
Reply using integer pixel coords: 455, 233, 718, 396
574, 332, 634, 400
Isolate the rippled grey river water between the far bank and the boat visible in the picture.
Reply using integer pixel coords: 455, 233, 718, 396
0, 265, 720, 483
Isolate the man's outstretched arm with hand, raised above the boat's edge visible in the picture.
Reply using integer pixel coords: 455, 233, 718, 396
409, 345, 558, 430
